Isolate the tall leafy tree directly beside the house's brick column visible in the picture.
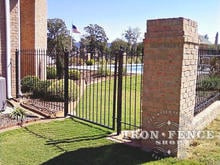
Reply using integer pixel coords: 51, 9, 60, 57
47, 18, 72, 79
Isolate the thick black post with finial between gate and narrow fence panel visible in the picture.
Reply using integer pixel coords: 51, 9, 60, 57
117, 47, 124, 135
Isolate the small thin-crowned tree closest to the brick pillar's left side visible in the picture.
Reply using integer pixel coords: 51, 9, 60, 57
123, 27, 141, 55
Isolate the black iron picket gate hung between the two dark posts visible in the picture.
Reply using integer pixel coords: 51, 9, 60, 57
68, 52, 117, 129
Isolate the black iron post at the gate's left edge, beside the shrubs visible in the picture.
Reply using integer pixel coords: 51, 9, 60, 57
64, 50, 69, 117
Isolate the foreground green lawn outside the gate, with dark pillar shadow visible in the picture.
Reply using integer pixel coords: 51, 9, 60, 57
0, 116, 220, 165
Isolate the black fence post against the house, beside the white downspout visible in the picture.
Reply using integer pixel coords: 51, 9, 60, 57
15, 49, 22, 98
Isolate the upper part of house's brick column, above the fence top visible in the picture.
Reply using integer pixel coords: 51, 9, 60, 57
20, 0, 47, 49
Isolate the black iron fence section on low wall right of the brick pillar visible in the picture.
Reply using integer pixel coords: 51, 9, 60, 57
194, 49, 220, 115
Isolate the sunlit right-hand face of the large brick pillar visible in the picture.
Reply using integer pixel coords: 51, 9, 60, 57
177, 20, 199, 157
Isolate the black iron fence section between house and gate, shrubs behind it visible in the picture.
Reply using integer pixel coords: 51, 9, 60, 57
16, 50, 65, 118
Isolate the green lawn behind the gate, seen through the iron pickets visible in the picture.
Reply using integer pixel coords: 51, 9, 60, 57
71, 75, 142, 129
